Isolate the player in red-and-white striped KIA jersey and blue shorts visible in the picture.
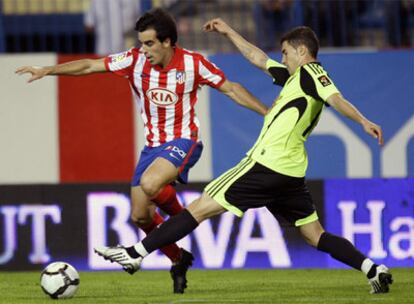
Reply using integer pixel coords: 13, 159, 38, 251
16, 9, 267, 293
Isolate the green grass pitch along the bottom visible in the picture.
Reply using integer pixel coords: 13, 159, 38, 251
0, 268, 414, 304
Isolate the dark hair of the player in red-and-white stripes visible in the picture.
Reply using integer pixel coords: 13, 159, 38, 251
135, 8, 177, 46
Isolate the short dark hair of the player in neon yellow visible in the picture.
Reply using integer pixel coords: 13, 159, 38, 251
280, 26, 319, 58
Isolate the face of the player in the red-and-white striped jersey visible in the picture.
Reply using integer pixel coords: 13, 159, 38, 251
138, 29, 172, 67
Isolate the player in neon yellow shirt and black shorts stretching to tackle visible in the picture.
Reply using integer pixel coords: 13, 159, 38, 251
96, 19, 392, 293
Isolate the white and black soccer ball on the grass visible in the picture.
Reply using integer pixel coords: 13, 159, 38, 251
40, 262, 79, 299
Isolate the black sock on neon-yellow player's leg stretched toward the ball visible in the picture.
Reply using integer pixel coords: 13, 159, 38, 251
142, 209, 198, 253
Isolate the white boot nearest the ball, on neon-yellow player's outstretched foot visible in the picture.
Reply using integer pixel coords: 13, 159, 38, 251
94, 246, 143, 274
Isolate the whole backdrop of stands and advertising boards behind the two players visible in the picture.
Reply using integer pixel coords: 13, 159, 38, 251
0, 0, 414, 270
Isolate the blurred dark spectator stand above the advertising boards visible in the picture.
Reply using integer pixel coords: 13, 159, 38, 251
0, 0, 414, 53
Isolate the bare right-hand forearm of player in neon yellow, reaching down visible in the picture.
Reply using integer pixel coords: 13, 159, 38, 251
327, 93, 384, 146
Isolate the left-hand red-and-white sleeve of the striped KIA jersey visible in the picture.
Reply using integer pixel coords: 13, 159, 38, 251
104, 48, 139, 77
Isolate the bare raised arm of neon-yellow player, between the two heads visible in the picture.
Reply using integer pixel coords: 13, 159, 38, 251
203, 18, 270, 75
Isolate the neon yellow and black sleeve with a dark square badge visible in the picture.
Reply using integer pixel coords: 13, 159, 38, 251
300, 63, 339, 102
